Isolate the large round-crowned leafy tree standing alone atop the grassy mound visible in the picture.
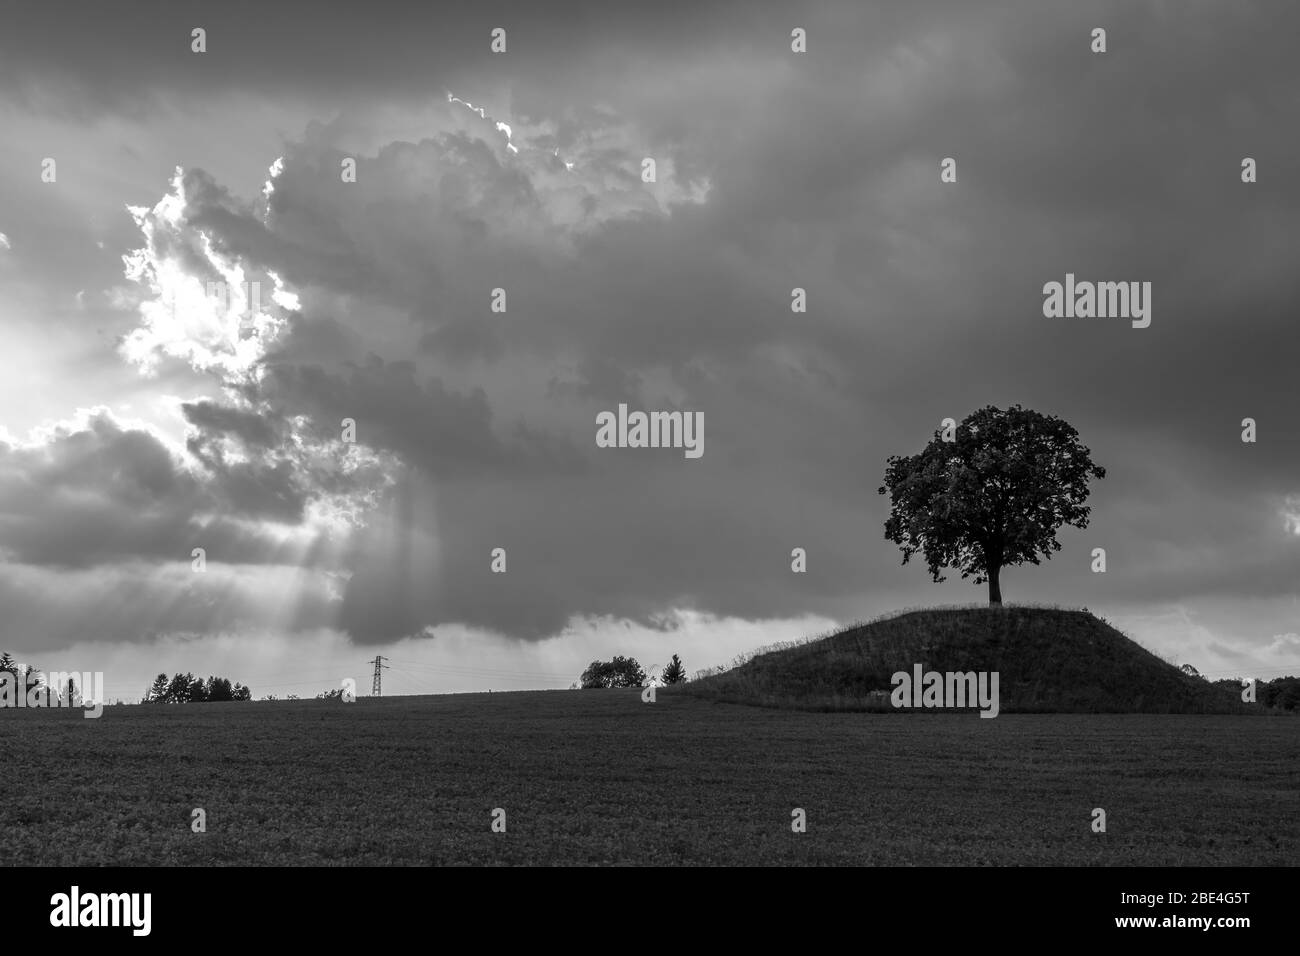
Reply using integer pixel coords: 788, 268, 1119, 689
880, 405, 1106, 605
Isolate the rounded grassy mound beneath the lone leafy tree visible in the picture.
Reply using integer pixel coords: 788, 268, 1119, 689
686, 606, 1264, 714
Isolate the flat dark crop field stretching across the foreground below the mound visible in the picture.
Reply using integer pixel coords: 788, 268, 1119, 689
0, 689, 1300, 865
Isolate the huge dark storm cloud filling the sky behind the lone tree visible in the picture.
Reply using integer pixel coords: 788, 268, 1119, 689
0, 3, 1300, 650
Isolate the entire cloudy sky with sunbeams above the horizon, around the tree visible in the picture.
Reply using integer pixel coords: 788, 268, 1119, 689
0, 0, 1300, 700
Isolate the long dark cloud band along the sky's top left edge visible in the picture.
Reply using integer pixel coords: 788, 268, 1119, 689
0, 0, 816, 108
